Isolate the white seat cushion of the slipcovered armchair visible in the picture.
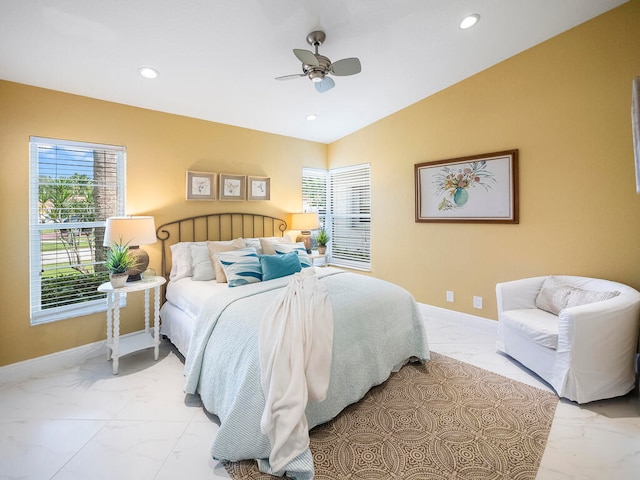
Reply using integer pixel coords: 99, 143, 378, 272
500, 308, 558, 350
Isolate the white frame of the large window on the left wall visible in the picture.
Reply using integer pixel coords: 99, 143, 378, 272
29, 136, 126, 325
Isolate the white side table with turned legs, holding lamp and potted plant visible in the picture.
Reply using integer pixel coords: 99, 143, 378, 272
98, 277, 166, 375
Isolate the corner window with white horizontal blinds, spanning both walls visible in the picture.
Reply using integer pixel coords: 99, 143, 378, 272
302, 164, 371, 270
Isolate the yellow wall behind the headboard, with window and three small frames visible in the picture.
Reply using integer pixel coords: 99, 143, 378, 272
0, 81, 327, 365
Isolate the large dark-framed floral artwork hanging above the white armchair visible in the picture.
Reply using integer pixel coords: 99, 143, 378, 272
414, 150, 518, 223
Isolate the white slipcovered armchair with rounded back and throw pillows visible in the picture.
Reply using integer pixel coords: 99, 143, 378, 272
496, 276, 640, 403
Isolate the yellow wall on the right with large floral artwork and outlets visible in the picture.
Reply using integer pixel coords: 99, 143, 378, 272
329, 0, 640, 318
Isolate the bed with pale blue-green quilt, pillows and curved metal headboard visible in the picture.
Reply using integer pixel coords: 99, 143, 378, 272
157, 213, 429, 480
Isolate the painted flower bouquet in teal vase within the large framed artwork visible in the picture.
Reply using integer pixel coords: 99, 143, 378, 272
433, 160, 496, 210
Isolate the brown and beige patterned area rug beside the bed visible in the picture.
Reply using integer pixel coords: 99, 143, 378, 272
226, 352, 558, 480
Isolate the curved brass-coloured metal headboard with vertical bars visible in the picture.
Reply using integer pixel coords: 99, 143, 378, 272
156, 213, 287, 286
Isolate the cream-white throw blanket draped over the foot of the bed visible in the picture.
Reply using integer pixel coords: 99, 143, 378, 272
259, 268, 333, 472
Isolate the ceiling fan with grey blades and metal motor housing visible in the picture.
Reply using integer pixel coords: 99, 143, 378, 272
276, 31, 362, 93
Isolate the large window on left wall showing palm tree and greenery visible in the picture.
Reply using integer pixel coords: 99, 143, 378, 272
29, 137, 126, 325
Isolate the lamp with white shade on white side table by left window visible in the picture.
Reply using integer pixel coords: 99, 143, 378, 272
103, 216, 157, 282
